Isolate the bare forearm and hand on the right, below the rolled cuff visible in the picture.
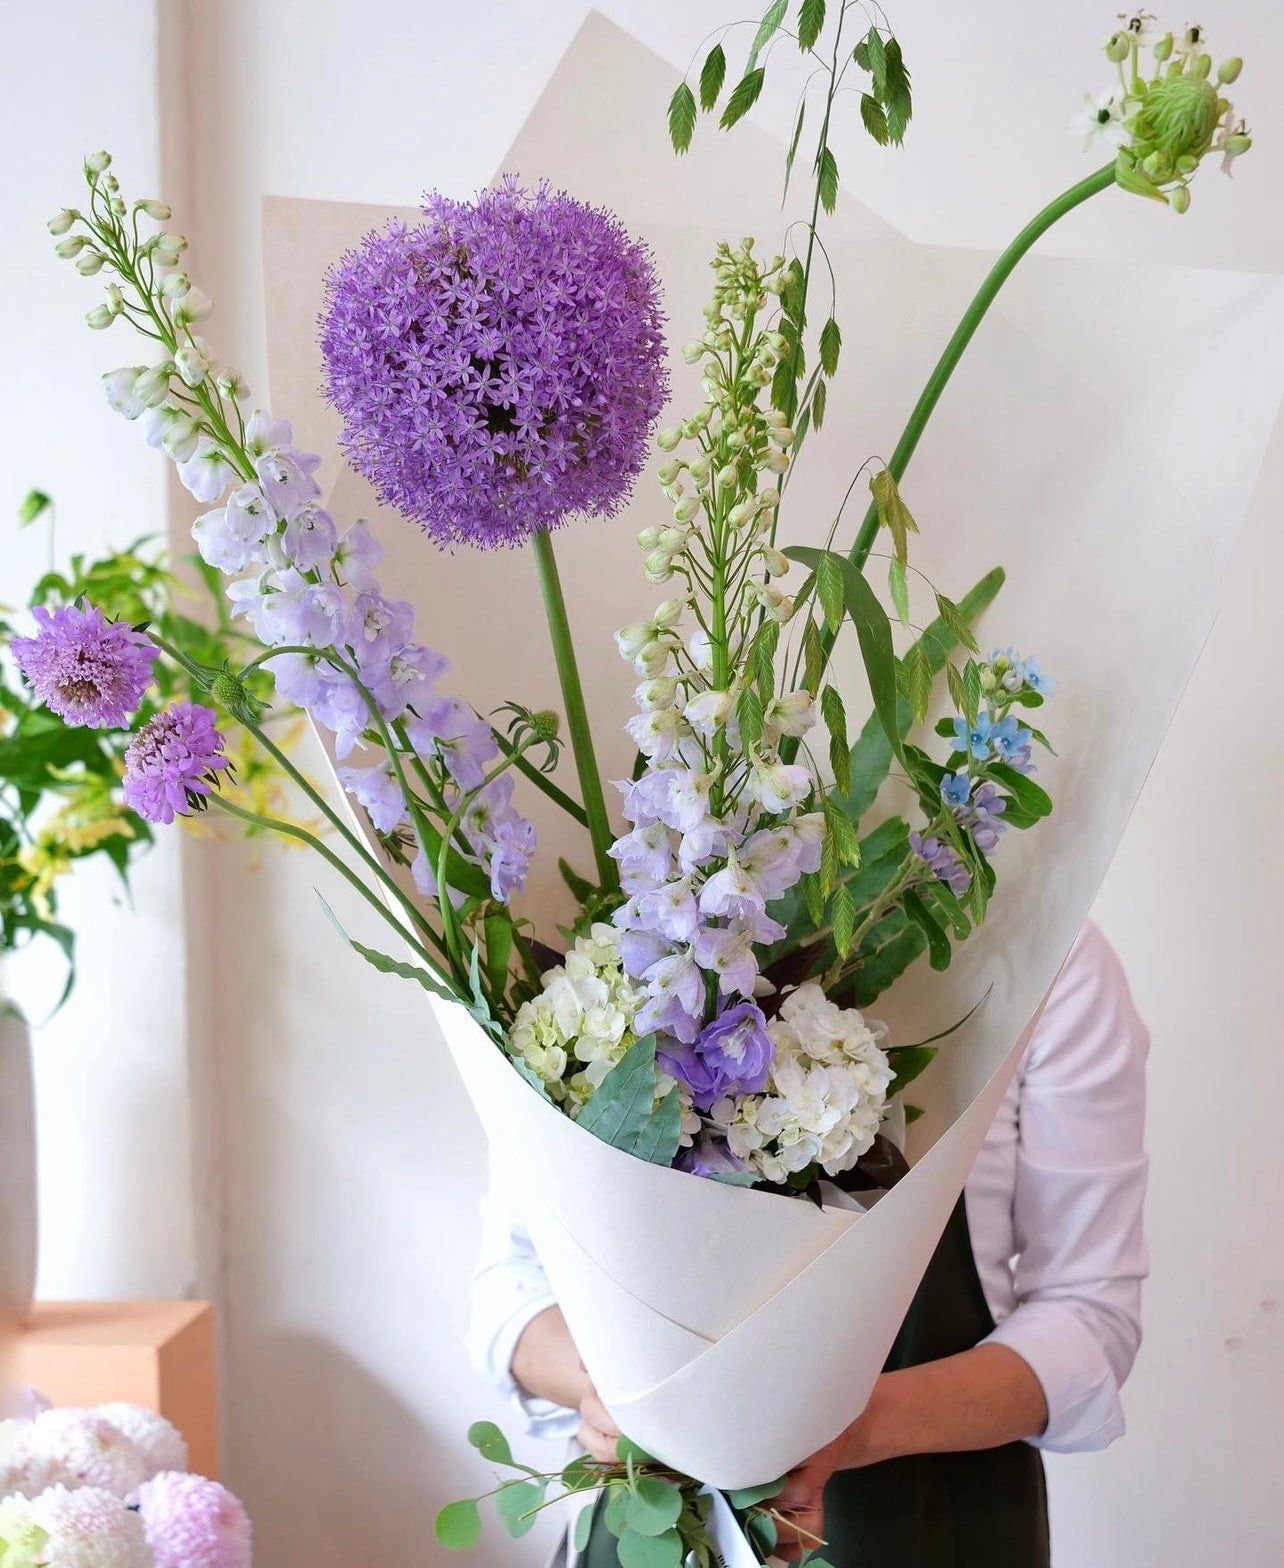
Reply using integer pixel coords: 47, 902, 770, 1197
773, 1345, 1047, 1562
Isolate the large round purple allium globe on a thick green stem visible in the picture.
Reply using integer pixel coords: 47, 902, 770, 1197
321, 179, 668, 547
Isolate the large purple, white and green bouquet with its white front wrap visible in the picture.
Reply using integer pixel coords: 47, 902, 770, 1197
20, 0, 1250, 1568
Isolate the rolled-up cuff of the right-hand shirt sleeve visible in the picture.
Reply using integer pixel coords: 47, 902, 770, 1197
981, 1301, 1124, 1454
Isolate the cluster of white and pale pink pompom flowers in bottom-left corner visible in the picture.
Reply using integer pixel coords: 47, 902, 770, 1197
0, 1391, 251, 1568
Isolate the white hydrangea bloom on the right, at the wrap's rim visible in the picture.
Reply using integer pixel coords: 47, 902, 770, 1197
710, 982, 892, 1185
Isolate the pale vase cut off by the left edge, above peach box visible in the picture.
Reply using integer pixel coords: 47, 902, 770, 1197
0, 1002, 36, 1323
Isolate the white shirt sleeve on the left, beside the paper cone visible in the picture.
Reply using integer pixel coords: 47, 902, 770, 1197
466, 1162, 580, 1439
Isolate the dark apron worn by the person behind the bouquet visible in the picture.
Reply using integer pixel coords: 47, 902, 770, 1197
583, 1196, 1050, 1568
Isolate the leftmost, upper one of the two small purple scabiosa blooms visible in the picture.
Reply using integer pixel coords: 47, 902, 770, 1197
11, 604, 157, 729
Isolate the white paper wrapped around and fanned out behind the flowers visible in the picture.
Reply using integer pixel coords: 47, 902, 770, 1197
265, 16, 1284, 1486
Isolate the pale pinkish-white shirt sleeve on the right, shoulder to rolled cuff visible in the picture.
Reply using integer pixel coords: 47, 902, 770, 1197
989, 925, 1148, 1452
